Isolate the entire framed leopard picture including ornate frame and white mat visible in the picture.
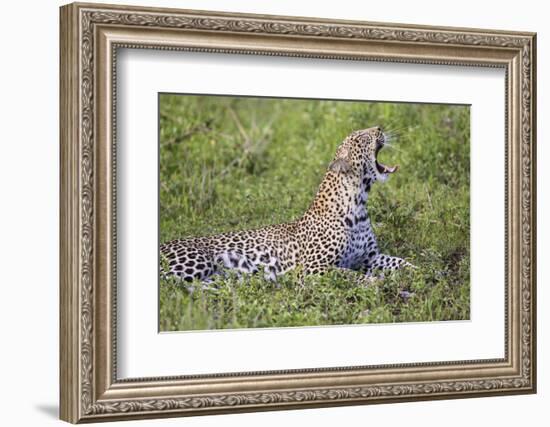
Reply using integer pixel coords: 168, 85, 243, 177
59, 3, 537, 423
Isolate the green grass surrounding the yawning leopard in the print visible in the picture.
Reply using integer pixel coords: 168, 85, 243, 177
160, 95, 470, 331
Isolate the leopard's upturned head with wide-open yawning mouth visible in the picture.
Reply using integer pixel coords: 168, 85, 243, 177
329, 126, 398, 186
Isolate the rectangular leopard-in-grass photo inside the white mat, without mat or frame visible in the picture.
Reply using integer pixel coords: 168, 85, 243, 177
159, 94, 470, 331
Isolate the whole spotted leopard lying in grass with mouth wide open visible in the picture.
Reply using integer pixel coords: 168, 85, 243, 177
160, 126, 414, 282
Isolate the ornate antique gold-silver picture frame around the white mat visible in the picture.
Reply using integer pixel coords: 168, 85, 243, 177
60, 4, 536, 423
